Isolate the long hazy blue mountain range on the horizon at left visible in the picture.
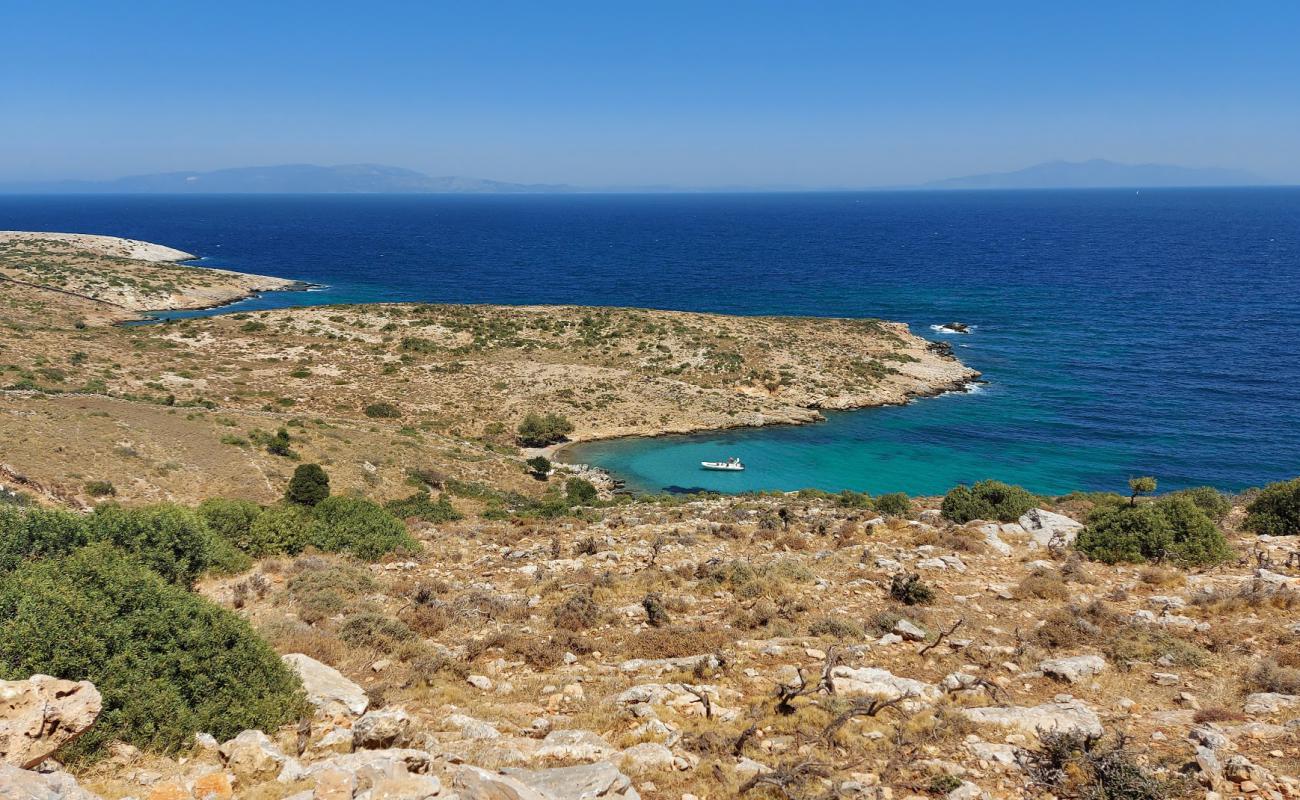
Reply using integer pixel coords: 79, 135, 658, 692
0, 164, 572, 194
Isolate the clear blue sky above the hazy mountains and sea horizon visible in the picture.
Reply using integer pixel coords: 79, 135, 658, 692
0, 0, 1300, 186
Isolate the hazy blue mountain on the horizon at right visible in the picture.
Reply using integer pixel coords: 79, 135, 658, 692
922, 159, 1266, 189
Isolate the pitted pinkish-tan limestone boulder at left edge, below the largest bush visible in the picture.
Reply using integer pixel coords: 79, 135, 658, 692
0, 675, 101, 769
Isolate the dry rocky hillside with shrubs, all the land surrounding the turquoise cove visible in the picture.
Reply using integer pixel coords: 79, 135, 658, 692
0, 237, 1300, 800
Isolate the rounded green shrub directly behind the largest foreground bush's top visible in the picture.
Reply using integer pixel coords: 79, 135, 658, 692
87, 503, 220, 587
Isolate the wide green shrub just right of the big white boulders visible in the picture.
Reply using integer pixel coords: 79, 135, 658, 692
1075, 497, 1232, 566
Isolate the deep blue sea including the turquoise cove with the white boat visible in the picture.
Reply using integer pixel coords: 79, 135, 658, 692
0, 189, 1300, 493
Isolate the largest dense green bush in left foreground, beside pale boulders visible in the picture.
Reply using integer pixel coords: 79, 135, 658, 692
0, 542, 304, 760
